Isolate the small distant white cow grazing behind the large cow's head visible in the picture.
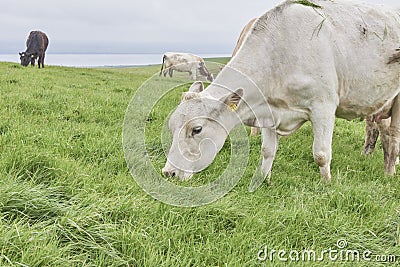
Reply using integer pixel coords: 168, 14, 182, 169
160, 52, 214, 82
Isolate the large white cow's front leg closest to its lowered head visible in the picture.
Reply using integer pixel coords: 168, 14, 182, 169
249, 128, 278, 192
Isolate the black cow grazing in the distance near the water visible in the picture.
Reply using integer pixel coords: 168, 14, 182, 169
19, 31, 49, 68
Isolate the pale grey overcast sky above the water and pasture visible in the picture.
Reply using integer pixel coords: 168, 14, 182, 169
0, 0, 400, 54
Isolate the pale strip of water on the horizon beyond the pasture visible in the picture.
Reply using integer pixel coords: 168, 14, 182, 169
0, 53, 230, 68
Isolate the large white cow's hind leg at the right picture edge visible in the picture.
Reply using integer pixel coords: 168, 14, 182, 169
385, 96, 400, 175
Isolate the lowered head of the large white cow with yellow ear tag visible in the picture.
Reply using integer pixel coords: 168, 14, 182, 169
162, 82, 243, 180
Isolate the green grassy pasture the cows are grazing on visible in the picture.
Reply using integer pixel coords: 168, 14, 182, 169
0, 60, 400, 266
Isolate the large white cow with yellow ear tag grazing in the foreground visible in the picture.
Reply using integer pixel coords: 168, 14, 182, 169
163, 0, 400, 186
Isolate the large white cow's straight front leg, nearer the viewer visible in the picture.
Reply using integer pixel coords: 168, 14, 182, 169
311, 104, 336, 182
